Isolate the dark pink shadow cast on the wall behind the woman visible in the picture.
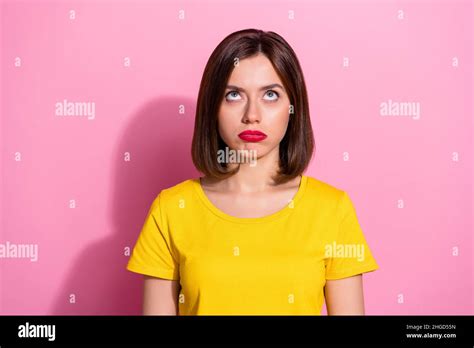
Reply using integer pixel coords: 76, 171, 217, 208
51, 97, 199, 315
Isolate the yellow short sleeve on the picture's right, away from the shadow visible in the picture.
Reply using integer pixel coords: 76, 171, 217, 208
324, 191, 379, 280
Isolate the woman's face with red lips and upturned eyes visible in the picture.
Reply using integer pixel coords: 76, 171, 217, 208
218, 54, 290, 162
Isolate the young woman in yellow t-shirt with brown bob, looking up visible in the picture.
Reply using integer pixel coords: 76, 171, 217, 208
127, 29, 378, 315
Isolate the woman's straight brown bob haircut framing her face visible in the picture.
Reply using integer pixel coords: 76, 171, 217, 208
191, 29, 314, 185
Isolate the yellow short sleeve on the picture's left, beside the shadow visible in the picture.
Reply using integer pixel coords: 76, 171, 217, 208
127, 193, 179, 280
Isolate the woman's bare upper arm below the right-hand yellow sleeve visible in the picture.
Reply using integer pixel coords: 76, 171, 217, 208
324, 274, 365, 315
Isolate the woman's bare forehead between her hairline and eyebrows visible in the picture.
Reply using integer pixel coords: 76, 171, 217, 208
229, 54, 282, 88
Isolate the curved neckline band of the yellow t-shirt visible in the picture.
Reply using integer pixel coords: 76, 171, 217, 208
191, 174, 308, 224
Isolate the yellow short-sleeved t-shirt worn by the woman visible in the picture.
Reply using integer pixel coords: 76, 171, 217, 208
127, 175, 378, 315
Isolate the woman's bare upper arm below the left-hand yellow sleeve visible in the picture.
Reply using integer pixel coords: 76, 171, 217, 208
143, 276, 180, 315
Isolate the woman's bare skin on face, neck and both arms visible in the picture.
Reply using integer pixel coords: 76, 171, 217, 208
143, 54, 364, 315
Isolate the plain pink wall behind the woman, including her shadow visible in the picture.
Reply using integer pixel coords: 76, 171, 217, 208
0, 0, 474, 314
